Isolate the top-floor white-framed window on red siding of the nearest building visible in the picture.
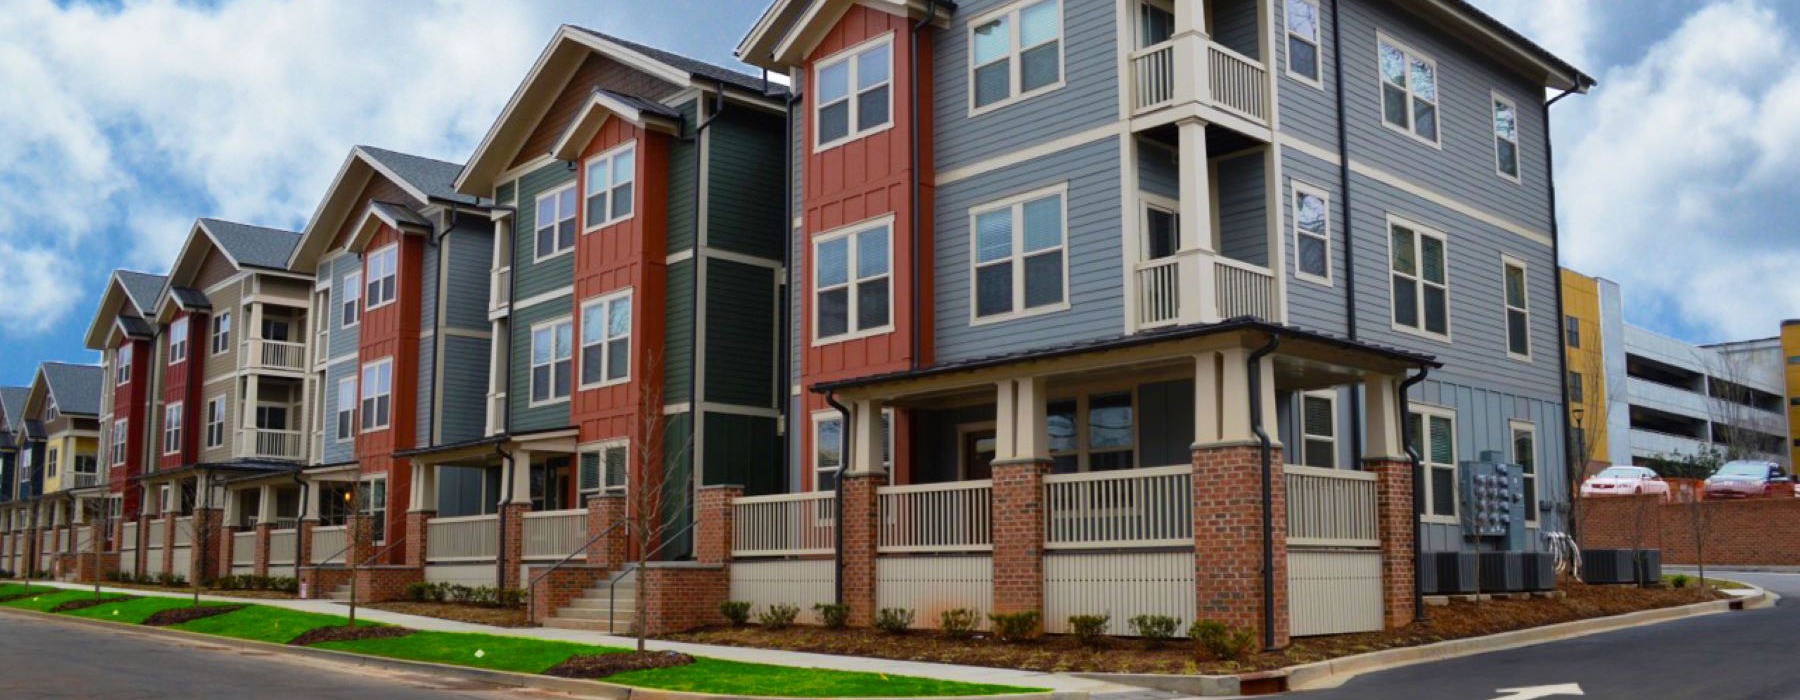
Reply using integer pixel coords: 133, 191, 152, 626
812, 36, 895, 151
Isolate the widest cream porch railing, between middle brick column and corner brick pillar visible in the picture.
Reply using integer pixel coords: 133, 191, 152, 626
1044, 466, 1193, 549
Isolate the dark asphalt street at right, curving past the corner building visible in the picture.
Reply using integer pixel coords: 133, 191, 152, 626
1291, 570, 1800, 700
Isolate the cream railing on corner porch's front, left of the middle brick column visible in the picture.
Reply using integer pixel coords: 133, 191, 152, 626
875, 480, 994, 552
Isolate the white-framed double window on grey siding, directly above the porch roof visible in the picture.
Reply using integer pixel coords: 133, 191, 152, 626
968, 185, 1069, 320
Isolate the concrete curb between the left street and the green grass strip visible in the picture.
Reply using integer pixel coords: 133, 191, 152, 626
0, 606, 1087, 700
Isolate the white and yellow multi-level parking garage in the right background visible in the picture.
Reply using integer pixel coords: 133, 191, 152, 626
1562, 270, 1795, 470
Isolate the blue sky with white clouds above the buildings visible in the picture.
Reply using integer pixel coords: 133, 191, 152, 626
0, 0, 1800, 383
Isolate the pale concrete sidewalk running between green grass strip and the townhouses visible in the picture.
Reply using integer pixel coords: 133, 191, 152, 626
14, 581, 1143, 695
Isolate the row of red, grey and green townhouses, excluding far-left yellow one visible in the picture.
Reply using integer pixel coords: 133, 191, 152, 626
7, 0, 1593, 646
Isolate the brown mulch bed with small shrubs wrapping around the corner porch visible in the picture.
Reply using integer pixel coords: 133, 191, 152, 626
664, 579, 1723, 675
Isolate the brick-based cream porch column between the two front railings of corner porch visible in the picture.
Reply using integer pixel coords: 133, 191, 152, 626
990, 376, 1049, 626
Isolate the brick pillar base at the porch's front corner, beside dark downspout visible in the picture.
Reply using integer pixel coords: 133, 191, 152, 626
1193, 444, 1289, 648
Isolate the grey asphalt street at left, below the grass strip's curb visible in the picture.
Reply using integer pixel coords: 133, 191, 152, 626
0, 614, 567, 700
